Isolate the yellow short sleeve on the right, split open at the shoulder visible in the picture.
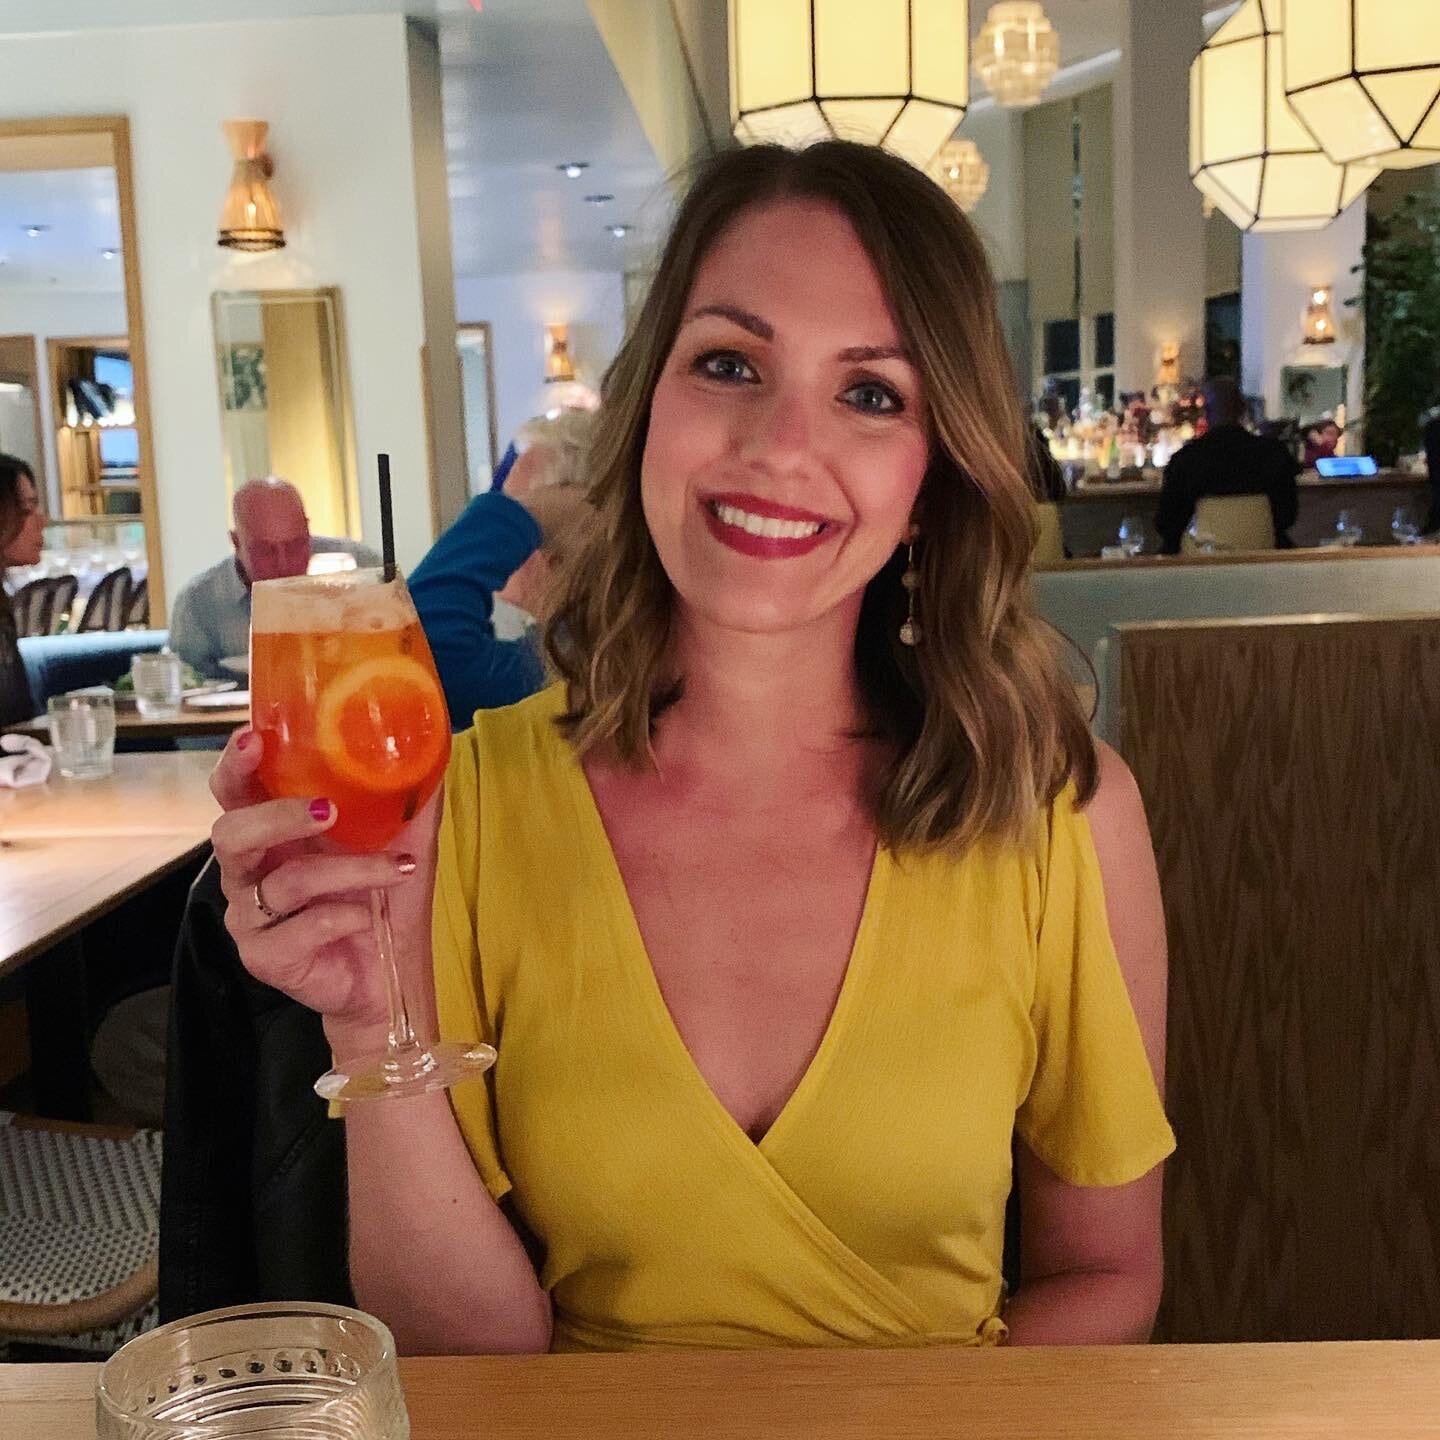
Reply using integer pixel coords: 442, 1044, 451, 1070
1015, 792, 1175, 1185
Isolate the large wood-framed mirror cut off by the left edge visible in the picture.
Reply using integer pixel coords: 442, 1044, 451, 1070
0, 117, 164, 613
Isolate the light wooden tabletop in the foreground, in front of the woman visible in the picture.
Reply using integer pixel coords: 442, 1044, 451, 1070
11, 1342, 1440, 1440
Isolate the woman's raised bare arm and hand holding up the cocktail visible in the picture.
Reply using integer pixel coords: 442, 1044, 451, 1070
210, 730, 550, 1354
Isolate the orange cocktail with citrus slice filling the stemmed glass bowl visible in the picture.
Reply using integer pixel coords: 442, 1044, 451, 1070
251, 570, 449, 851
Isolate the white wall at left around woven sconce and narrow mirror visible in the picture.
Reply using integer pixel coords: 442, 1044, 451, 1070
0, 16, 464, 613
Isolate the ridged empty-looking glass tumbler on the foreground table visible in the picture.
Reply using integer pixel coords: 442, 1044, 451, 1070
95, 1300, 410, 1440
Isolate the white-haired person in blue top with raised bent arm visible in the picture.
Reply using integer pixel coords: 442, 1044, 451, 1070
409, 410, 593, 729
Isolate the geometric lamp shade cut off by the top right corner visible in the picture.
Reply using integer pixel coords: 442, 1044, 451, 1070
1283, 0, 1440, 170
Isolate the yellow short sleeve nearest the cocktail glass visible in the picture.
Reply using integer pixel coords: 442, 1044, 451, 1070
431, 729, 511, 1201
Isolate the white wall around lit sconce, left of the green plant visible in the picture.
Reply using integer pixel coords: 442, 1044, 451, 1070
1240, 196, 1365, 423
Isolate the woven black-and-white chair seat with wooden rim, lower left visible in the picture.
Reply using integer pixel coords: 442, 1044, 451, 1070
0, 1116, 160, 1355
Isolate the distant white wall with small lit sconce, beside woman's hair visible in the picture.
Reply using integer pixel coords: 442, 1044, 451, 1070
455, 271, 625, 469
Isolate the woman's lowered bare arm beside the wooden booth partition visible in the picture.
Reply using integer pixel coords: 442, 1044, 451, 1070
1005, 746, 1166, 1345
